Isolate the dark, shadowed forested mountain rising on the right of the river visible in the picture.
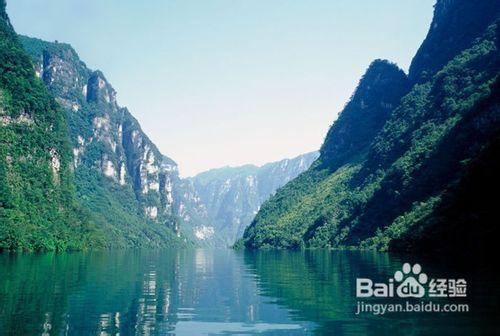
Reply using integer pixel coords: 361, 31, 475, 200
238, 0, 500, 253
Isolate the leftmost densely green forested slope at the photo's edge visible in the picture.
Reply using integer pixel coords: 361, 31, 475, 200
0, 0, 103, 250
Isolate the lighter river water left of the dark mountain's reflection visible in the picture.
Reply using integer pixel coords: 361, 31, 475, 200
0, 250, 312, 335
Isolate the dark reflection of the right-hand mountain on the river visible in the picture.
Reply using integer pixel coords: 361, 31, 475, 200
240, 250, 500, 335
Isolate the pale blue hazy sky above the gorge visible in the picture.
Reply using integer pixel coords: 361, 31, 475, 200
7, 0, 435, 176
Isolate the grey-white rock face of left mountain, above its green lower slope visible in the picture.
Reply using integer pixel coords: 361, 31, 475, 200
21, 37, 180, 236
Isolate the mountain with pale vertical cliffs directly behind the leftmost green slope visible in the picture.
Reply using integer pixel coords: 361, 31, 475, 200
19, 36, 186, 247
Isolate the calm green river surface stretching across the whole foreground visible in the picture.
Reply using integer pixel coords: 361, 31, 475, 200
0, 250, 500, 335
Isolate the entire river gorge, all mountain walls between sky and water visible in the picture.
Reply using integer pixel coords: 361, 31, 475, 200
0, 0, 499, 255
